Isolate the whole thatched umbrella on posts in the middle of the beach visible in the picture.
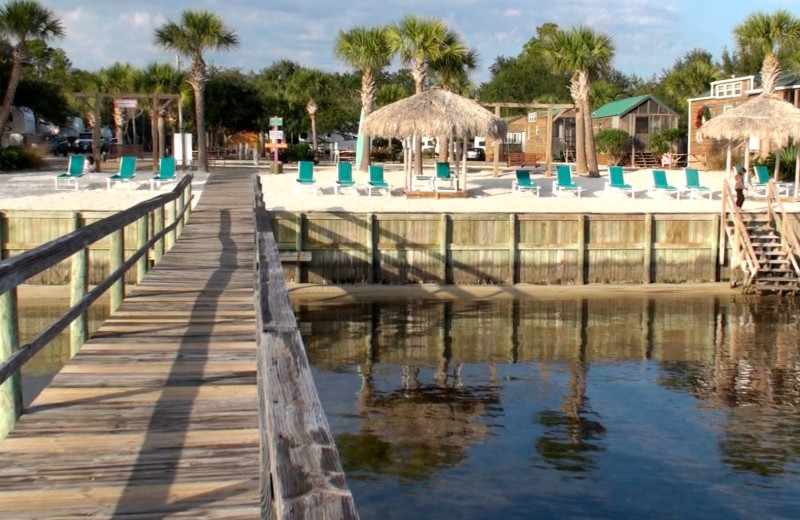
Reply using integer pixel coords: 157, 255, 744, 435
361, 88, 506, 190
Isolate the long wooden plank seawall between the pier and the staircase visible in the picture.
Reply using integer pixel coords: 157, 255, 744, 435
271, 211, 744, 284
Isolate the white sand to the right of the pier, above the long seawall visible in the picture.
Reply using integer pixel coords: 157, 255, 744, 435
261, 163, 800, 213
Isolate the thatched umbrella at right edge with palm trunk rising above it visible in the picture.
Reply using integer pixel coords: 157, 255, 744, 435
697, 54, 800, 197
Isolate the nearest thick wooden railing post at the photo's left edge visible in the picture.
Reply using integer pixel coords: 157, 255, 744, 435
0, 214, 22, 441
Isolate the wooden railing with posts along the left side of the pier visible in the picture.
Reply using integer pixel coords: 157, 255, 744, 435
0, 175, 192, 440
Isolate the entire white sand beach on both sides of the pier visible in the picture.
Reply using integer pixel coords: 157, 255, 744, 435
0, 161, 800, 213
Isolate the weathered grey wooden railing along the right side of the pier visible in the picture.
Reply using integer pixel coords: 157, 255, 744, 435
254, 175, 358, 519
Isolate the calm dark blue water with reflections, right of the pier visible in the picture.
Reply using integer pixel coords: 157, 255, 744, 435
298, 298, 800, 520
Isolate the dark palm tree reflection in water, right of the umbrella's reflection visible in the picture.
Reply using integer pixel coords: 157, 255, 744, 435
536, 300, 606, 472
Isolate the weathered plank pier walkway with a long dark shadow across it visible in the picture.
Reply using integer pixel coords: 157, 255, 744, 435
0, 169, 260, 520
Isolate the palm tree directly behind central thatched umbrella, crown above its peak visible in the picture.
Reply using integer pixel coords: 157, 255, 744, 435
387, 14, 452, 175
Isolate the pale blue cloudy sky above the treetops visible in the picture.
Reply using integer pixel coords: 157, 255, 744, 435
39, 0, 800, 85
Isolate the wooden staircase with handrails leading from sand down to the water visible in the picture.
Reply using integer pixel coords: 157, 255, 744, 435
720, 182, 800, 294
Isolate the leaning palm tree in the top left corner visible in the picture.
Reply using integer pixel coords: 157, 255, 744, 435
0, 0, 64, 138
